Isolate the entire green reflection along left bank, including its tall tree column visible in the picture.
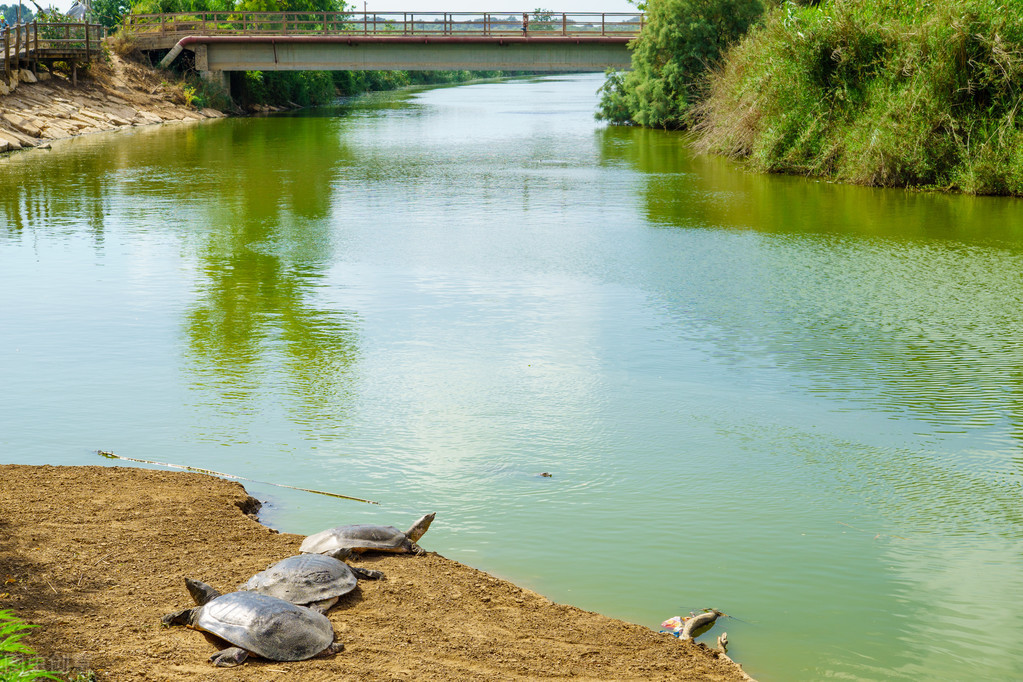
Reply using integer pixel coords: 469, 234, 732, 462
0, 111, 358, 429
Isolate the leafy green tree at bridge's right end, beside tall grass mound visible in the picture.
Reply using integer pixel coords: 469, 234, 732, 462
597, 0, 763, 129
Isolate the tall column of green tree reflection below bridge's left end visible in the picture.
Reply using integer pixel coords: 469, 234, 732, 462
180, 113, 357, 430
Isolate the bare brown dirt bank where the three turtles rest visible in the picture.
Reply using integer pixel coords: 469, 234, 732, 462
0, 465, 749, 682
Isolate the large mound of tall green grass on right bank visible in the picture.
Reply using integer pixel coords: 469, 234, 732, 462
698, 0, 1023, 195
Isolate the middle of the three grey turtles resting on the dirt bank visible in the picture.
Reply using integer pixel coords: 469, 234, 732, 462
238, 554, 384, 613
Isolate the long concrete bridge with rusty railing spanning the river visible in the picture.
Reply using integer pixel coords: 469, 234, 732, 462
127, 11, 643, 88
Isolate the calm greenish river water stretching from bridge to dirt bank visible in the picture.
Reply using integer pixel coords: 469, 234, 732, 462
0, 75, 1023, 682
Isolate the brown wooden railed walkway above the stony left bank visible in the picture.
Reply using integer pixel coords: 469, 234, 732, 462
0, 21, 103, 84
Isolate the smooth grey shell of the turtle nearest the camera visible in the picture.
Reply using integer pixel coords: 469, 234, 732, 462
192, 592, 333, 661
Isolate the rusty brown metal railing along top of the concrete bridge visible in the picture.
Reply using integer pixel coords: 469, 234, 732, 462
126, 11, 643, 38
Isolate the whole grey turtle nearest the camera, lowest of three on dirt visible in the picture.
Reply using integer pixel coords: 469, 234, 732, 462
163, 579, 345, 668
